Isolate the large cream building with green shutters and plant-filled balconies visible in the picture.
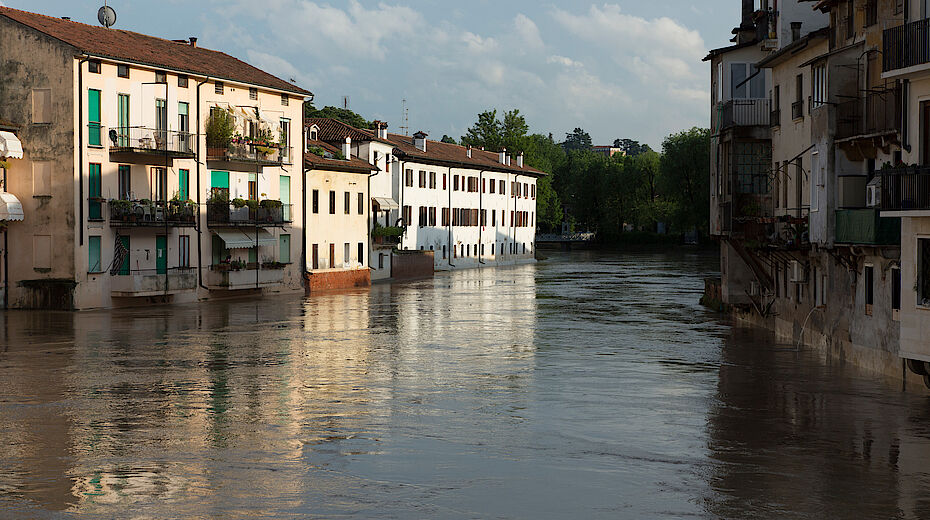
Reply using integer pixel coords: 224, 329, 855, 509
0, 7, 309, 309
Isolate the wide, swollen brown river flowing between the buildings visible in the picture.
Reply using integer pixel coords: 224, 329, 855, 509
0, 251, 930, 519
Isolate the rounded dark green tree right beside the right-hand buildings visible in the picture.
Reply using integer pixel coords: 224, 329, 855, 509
657, 127, 710, 232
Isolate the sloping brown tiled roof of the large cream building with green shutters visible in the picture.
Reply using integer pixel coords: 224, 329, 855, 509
0, 7, 311, 95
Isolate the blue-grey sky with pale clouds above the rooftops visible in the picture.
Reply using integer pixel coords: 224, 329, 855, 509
0, 0, 740, 147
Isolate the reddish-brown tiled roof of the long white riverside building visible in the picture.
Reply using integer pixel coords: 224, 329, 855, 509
388, 134, 546, 177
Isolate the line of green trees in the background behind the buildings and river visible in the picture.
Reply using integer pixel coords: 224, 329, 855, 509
305, 105, 710, 242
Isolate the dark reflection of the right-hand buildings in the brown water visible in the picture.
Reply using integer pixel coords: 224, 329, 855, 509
706, 329, 930, 518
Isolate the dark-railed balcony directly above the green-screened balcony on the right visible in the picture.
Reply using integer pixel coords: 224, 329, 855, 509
836, 86, 901, 140
